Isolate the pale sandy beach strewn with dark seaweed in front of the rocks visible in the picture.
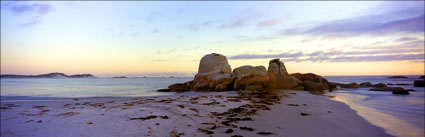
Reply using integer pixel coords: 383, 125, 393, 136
1, 90, 390, 137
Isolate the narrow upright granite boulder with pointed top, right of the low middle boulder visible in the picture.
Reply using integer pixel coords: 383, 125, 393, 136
268, 59, 303, 89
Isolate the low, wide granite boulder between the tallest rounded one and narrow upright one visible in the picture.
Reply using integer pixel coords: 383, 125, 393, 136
233, 65, 276, 91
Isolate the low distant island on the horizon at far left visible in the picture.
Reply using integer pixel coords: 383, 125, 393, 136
0, 72, 95, 78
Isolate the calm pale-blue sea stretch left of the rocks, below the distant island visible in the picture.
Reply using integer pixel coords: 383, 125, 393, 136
1, 78, 192, 100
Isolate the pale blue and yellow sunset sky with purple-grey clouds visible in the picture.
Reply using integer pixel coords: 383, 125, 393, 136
1, 1, 425, 76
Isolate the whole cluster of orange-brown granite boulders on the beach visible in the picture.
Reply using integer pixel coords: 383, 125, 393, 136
158, 53, 336, 92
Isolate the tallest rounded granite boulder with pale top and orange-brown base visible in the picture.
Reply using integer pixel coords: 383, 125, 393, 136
192, 53, 234, 91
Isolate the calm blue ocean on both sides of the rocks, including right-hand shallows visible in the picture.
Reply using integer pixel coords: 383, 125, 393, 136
1, 76, 425, 137
